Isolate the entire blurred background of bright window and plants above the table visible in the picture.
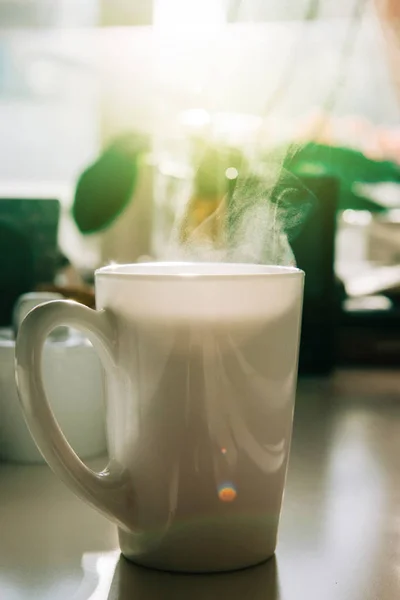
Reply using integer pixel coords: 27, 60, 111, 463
0, 0, 400, 374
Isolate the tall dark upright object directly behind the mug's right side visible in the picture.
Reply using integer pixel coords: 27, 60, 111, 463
292, 176, 340, 375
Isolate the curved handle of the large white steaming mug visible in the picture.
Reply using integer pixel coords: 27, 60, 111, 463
15, 300, 133, 530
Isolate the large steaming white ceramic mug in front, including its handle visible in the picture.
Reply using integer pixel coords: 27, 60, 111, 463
16, 263, 303, 572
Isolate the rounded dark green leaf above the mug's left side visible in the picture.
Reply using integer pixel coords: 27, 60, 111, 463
72, 134, 148, 234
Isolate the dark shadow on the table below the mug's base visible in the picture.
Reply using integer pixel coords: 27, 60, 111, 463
108, 556, 279, 600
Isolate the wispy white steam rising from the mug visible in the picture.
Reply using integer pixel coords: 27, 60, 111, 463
164, 148, 315, 266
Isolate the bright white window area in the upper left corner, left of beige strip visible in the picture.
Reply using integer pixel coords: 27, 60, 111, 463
0, 0, 99, 183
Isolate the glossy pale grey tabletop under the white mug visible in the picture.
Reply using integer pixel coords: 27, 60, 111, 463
0, 372, 400, 600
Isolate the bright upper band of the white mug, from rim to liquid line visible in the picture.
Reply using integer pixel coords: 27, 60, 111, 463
96, 262, 304, 327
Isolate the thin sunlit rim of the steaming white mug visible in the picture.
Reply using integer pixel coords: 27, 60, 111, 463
95, 261, 304, 280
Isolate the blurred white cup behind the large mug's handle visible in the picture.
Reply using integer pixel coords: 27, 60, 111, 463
0, 292, 107, 463
